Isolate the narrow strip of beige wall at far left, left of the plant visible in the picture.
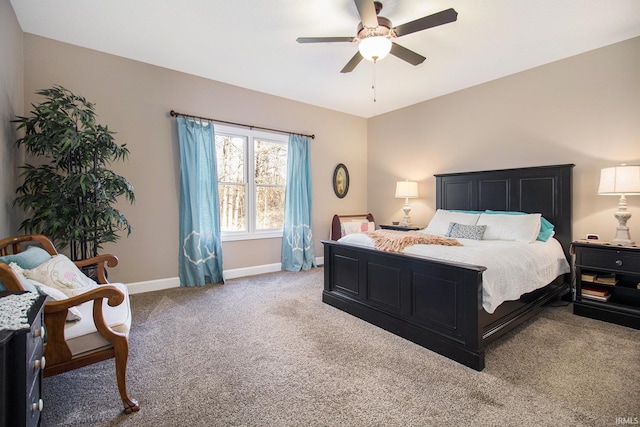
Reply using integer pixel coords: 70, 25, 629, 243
0, 0, 24, 237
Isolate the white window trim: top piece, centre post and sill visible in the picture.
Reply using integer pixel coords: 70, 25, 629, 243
214, 124, 289, 242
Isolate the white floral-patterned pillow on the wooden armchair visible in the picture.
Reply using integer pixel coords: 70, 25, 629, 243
24, 254, 98, 297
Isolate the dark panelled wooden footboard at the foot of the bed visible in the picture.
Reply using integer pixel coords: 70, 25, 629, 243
322, 241, 485, 370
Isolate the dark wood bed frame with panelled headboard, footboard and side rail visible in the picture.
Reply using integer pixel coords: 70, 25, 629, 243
322, 164, 574, 371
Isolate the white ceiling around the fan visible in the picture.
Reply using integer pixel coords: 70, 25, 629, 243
11, 0, 640, 117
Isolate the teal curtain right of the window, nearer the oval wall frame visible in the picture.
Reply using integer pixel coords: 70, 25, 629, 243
282, 135, 316, 271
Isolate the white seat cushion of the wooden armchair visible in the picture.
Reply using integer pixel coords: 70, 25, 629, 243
64, 283, 131, 356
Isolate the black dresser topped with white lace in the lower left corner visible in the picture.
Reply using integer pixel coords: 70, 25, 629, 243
0, 292, 46, 427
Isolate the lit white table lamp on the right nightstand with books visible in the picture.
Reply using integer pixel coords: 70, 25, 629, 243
598, 165, 640, 246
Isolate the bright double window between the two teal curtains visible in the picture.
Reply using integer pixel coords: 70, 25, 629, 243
215, 125, 288, 240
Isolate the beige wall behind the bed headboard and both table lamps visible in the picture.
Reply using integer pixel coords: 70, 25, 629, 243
368, 38, 640, 241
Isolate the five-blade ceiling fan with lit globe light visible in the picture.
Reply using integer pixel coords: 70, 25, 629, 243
296, 0, 458, 73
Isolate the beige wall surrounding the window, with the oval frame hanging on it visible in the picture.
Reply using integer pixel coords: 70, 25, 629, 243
24, 34, 367, 282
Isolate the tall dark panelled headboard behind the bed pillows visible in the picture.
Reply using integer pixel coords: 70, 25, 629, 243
435, 164, 575, 258
